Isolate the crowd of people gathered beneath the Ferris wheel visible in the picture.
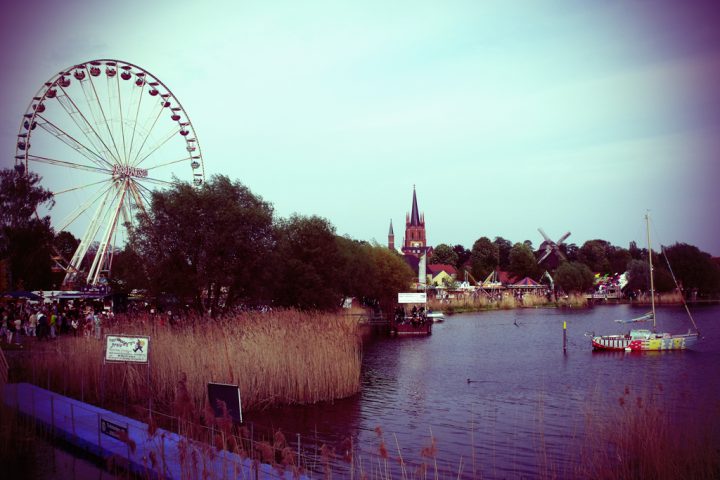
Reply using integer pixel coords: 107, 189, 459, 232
0, 301, 113, 345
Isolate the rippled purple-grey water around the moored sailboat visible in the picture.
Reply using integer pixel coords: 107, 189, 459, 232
246, 305, 720, 479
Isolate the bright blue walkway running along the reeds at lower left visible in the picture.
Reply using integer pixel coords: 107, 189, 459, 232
3, 383, 306, 480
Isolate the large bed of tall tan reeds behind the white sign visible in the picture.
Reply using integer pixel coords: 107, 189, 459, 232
20, 311, 362, 411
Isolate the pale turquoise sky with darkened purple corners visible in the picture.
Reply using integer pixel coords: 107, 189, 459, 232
0, 0, 720, 256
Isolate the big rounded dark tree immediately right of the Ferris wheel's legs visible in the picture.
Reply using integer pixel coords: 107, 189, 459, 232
131, 175, 273, 315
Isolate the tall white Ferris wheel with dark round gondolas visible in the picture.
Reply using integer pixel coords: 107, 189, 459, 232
15, 59, 205, 288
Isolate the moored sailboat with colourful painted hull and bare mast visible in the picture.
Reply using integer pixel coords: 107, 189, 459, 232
592, 214, 699, 352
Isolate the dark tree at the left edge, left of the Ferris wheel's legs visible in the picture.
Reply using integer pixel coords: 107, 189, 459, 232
0, 168, 54, 290
